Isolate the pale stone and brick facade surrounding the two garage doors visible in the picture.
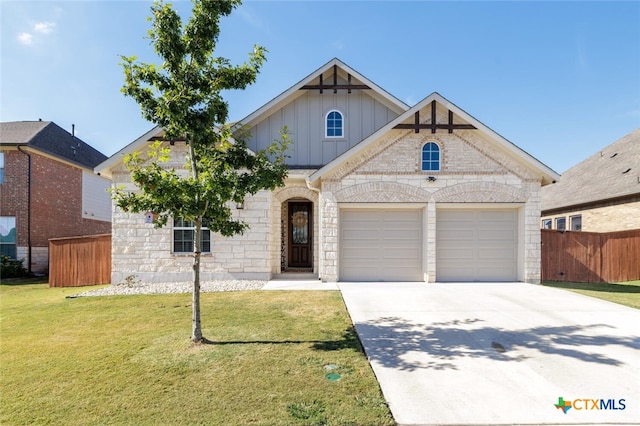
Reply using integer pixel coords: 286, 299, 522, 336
312, 131, 540, 282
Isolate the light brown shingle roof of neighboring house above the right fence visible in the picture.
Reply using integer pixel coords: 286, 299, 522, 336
542, 128, 640, 215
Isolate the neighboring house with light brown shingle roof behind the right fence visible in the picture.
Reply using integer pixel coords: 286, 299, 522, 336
542, 128, 640, 232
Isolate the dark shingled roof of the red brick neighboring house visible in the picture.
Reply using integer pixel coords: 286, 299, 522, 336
0, 121, 107, 169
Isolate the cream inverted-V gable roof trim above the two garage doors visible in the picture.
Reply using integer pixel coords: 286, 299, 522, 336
308, 92, 560, 185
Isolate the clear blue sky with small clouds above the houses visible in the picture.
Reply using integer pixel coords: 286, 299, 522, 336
0, 0, 640, 172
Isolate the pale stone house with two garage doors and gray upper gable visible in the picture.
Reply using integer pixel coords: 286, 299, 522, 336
96, 59, 559, 283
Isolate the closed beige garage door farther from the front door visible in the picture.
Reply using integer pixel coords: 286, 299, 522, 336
436, 210, 518, 281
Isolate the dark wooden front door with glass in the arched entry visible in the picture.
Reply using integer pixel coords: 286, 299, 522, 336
288, 202, 313, 268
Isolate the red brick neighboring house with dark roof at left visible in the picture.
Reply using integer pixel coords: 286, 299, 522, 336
0, 121, 111, 273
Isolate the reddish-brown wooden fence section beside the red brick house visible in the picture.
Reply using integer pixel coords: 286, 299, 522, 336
49, 234, 111, 287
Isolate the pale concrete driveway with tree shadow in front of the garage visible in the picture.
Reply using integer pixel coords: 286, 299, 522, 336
338, 283, 640, 425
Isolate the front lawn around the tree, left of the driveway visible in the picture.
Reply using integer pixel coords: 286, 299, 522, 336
0, 282, 394, 426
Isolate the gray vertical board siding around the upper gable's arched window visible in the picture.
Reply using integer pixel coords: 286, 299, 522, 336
247, 90, 398, 167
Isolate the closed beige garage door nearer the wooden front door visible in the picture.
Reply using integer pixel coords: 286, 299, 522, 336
339, 210, 423, 281
